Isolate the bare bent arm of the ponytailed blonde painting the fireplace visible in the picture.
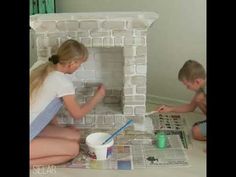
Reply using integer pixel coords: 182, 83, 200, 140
63, 85, 105, 119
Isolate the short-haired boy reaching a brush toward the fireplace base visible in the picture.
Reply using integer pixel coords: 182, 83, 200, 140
156, 60, 207, 141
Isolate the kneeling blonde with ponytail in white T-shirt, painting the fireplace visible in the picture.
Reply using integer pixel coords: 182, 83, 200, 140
30, 39, 105, 167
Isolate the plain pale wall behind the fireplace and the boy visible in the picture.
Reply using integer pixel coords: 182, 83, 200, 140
56, 0, 206, 102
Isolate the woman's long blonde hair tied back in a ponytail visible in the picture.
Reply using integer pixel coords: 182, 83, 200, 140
30, 39, 88, 99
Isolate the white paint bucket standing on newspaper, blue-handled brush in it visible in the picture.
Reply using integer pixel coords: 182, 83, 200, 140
85, 132, 114, 160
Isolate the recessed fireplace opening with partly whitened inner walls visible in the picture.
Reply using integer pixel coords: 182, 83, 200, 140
73, 47, 124, 115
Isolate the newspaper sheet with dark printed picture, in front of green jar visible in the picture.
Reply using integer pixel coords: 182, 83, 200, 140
132, 135, 189, 169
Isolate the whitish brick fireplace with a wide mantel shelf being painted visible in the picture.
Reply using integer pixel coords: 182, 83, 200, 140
30, 12, 158, 128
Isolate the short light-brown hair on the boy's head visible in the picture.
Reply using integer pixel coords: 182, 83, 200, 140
178, 60, 206, 82
